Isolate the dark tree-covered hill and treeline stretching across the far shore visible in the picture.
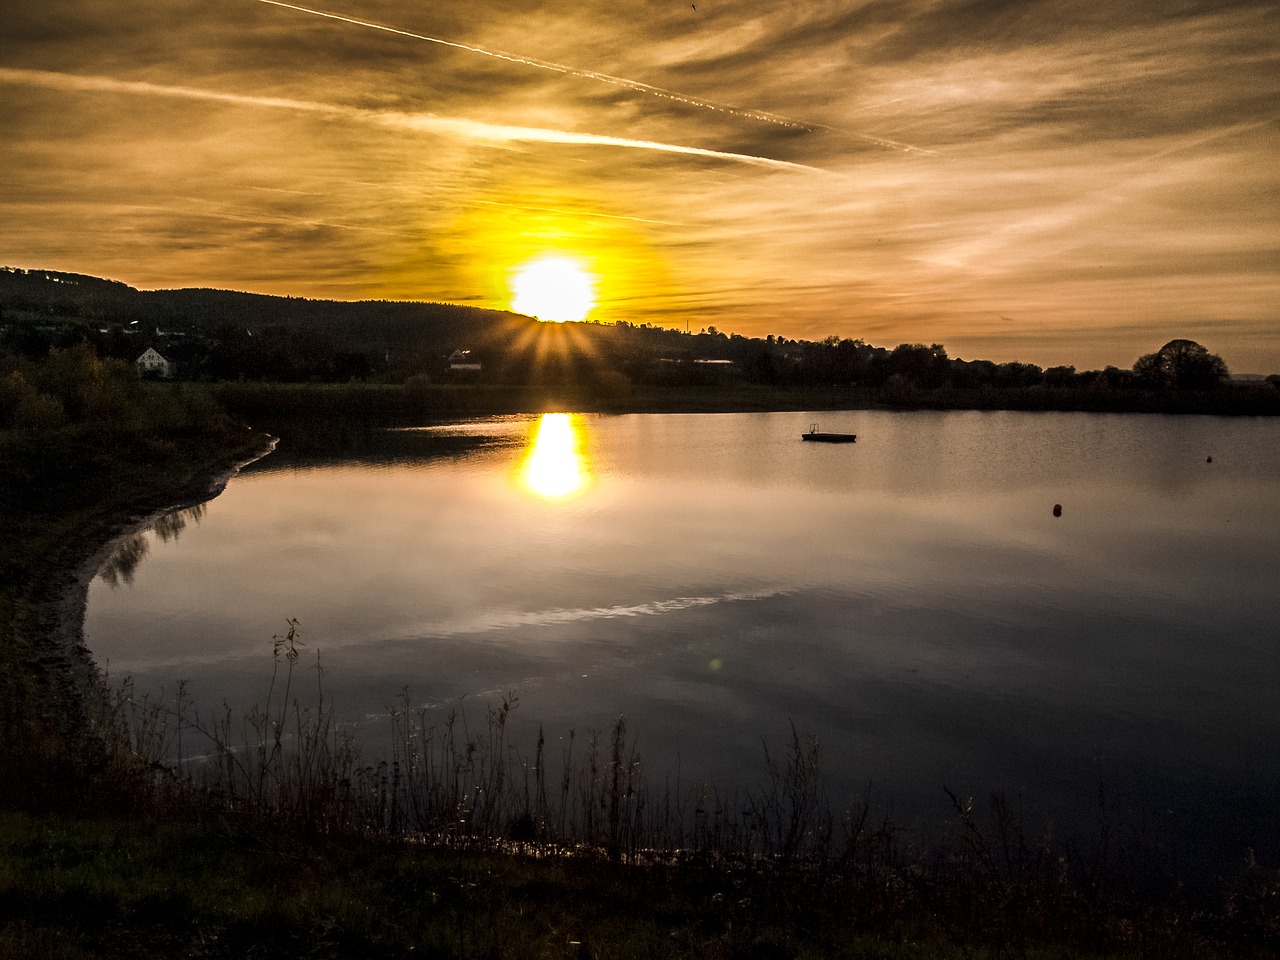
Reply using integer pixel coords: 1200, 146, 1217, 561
0, 268, 1280, 415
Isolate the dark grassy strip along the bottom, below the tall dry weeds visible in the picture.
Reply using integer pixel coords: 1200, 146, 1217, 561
0, 814, 1268, 960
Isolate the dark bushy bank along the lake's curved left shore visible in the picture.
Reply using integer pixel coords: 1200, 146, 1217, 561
0, 348, 268, 803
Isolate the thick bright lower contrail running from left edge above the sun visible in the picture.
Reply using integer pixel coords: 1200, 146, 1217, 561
0, 67, 827, 173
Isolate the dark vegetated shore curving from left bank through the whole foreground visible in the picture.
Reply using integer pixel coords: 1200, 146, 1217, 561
0, 320, 1280, 959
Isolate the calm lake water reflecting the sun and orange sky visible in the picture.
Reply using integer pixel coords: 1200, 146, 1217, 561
87, 412, 1280, 863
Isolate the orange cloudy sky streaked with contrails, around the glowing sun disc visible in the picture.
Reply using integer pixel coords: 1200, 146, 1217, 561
0, 0, 1280, 374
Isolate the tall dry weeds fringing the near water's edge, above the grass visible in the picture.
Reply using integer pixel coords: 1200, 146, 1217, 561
82, 621, 1280, 957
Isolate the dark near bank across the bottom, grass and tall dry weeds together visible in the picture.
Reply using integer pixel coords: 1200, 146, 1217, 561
0, 686, 1280, 960
